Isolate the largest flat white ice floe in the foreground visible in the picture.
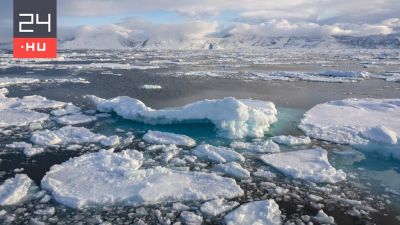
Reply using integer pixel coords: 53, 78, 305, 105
41, 150, 243, 208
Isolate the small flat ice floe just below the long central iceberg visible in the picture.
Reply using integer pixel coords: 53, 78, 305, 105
142, 130, 196, 147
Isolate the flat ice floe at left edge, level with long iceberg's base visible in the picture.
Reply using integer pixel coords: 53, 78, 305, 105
0, 109, 49, 127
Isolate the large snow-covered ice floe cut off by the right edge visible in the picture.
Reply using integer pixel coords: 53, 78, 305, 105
300, 99, 400, 159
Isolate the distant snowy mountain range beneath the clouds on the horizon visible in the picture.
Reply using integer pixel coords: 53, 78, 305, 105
0, 34, 400, 50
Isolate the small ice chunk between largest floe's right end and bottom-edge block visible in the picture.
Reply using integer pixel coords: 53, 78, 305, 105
200, 198, 239, 217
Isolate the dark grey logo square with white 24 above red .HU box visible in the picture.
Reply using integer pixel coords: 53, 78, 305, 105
14, 0, 57, 38
